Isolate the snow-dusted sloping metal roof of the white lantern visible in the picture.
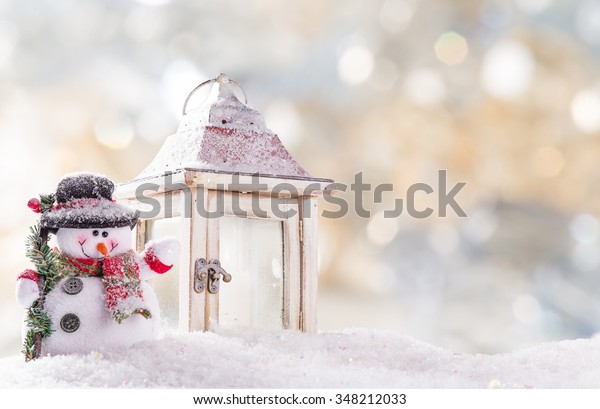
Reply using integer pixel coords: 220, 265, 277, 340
136, 74, 311, 179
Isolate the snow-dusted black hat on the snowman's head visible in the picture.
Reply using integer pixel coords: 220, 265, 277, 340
40, 173, 139, 231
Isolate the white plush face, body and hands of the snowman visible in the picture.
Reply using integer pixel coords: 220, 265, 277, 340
17, 227, 179, 355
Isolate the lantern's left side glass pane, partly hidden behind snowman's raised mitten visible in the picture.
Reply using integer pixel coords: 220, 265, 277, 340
146, 217, 181, 330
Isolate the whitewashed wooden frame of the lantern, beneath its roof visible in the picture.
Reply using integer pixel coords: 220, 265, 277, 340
115, 169, 332, 332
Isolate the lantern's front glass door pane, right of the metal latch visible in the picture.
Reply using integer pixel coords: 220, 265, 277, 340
219, 216, 284, 329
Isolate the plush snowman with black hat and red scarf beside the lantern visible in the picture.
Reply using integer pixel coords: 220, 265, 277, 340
16, 173, 179, 355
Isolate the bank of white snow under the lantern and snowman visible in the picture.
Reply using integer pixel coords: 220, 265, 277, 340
0, 329, 600, 388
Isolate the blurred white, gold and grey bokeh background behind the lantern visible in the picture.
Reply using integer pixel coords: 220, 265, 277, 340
0, 0, 600, 355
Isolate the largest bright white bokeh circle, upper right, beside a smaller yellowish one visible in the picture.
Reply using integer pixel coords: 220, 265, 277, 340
481, 40, 535, 100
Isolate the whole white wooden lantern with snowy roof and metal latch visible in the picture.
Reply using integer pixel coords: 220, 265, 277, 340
115, 74, 333, 331
